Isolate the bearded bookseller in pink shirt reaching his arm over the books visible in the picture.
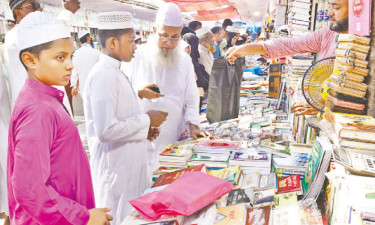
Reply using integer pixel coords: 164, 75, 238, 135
226, 0, 349, 116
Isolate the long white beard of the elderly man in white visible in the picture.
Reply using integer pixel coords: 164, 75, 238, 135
149, 36, 182, 69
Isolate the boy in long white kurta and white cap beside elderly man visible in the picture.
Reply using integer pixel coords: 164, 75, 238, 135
84, 12, 167, 225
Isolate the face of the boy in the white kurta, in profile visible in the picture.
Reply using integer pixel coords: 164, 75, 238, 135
116, 31, 137, 62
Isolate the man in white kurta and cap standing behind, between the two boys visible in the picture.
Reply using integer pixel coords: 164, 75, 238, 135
70, 31, 100, 96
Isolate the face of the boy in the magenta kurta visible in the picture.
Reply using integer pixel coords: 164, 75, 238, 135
26, 38, 74, 86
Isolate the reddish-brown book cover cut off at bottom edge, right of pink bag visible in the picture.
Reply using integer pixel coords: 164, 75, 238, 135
246, 206, 271, 225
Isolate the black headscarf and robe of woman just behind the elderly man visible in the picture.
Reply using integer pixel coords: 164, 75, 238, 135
182, 33, 210, 91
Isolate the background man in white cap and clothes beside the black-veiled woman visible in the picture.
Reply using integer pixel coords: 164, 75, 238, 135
196, 27, 216, 75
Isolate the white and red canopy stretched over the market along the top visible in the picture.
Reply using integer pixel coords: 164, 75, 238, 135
34, 0, 269, 22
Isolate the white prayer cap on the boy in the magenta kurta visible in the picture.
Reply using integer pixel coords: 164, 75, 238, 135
17, 11, 71, 50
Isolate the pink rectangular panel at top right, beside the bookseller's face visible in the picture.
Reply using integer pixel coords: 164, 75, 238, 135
349, 0, 371, 36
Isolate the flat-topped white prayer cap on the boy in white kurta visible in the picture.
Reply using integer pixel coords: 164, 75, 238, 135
98, 12, 134, 30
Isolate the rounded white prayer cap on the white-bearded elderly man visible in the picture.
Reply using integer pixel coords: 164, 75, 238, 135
155, 2, 182, 27
